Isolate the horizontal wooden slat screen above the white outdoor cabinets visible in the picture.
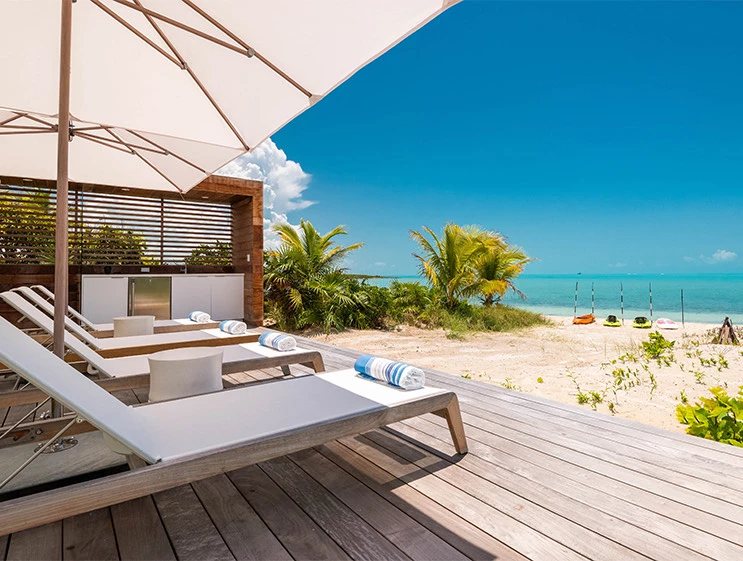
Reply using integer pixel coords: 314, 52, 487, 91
0, 185, 232, 265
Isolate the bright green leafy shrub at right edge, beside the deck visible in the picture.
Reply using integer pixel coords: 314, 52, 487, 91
676, 386, 743, 447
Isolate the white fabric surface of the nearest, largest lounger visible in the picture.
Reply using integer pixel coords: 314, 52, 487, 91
0, 318, 446, 463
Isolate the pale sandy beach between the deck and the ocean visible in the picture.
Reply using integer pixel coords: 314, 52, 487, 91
322, 317, 743, 431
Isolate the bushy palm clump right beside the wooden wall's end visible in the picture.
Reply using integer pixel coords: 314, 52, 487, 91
264, 220, 365, 332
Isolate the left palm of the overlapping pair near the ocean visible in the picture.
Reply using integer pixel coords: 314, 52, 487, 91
410, 223, 502, 310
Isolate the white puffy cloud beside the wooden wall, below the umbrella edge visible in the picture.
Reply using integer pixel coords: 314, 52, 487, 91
217, 138, 314, 249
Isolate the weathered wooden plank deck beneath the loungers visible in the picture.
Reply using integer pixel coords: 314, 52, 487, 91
0, 334, 743, 561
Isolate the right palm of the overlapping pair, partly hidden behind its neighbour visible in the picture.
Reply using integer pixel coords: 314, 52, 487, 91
475, 243, 534, 307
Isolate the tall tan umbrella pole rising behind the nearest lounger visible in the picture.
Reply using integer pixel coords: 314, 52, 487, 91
52, 0, 72, 417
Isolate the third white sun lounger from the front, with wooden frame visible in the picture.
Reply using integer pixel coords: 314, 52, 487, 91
0, 290, 259, 358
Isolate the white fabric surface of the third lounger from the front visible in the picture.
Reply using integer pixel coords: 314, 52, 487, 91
0, 289, 253, 350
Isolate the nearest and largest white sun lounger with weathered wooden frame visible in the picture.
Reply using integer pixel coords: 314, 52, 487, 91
0, 318, 467, 533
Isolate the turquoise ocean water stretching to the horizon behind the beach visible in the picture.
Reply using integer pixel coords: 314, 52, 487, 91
374, 274, 743, 325
